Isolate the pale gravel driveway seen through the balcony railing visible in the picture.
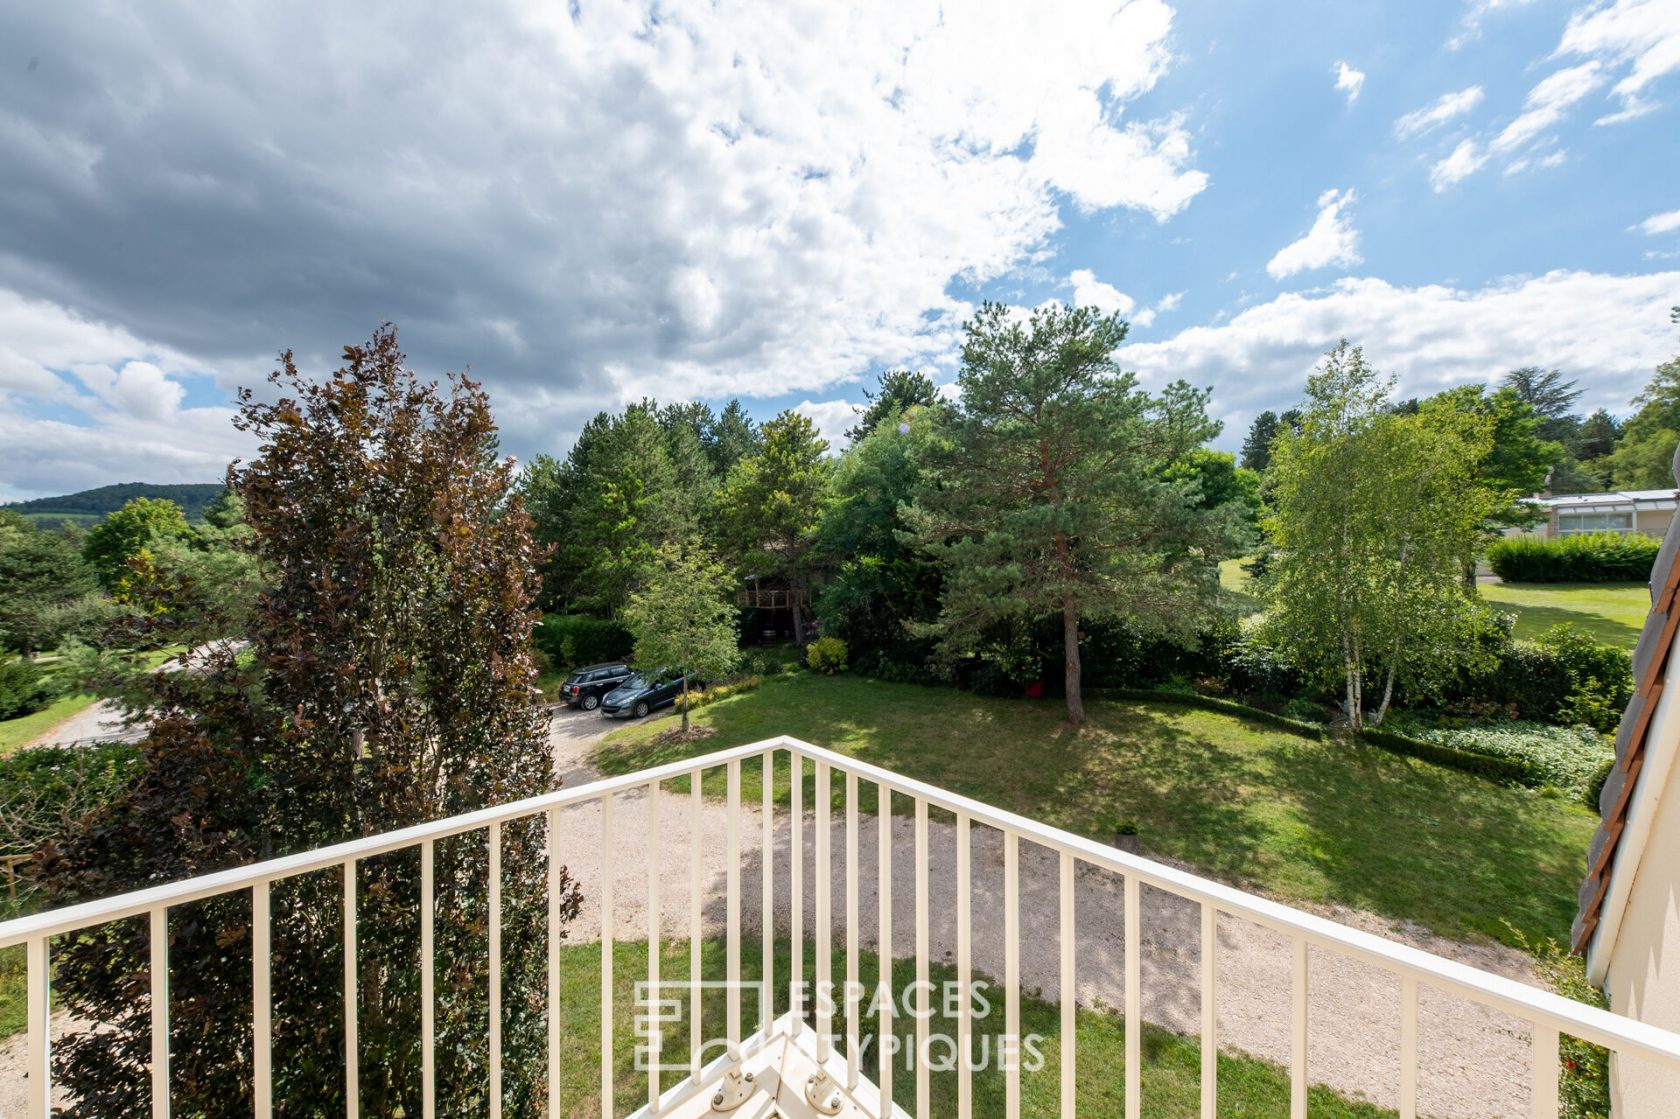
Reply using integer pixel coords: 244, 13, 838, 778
0, 709, 1534, 1119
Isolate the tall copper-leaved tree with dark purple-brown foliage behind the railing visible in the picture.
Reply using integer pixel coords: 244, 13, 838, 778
40, 326, 580, 1116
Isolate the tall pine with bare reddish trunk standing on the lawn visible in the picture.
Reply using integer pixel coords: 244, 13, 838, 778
914, 302, 1235, 726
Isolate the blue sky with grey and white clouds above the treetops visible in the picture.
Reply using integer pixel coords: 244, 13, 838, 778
0, 0, 1680, 497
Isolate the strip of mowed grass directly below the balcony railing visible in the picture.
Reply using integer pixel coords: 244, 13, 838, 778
561, 938, 1394, 1119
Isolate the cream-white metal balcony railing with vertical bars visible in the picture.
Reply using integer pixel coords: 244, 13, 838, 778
0, 738, 1680, 1119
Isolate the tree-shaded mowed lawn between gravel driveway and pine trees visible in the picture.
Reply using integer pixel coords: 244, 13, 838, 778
596, 674, 1596, 944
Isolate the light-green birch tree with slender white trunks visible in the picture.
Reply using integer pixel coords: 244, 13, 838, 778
1262, 341, 1497, 729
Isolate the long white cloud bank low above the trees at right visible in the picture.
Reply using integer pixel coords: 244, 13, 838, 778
1117, 272, 1680, 428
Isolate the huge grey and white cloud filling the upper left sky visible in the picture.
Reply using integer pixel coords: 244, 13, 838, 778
0, 0, 1208, 486
